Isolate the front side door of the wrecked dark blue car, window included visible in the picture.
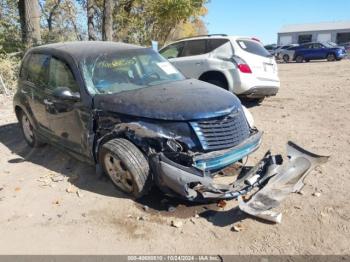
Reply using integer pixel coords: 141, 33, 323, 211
46, 56, 87, 155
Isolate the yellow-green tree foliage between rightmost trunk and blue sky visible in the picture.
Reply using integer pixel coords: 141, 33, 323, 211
114, 0, 206, 45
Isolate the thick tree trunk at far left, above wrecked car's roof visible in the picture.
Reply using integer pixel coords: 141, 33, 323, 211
18, 0, 41, 48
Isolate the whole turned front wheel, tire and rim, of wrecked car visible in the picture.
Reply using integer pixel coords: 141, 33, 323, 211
99, 138, 151, 198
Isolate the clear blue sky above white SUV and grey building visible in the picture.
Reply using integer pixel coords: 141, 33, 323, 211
204, 0, 350, 44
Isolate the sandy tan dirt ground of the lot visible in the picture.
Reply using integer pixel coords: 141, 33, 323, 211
0, 60, 350, 254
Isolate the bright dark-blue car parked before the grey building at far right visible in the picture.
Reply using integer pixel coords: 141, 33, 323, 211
294, 42, 346, 63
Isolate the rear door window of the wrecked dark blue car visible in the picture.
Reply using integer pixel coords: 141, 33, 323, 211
25, 54, 50, 88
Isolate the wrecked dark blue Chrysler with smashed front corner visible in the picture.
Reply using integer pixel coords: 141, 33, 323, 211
13, 39, 268, 201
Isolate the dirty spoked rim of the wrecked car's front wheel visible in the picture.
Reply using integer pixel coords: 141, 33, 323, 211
103, 153, 134, 193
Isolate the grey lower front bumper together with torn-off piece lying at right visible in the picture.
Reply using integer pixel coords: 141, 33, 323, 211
152, 137, 327, 205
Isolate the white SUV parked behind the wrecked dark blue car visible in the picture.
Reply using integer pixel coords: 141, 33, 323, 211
159, 35, 280, 101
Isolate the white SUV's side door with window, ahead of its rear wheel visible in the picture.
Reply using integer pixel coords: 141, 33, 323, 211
170, 39, 207, 79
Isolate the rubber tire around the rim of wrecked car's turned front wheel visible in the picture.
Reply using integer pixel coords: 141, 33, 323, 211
99, 138, 151, 198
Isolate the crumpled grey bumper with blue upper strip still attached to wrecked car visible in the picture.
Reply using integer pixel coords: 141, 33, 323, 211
152, 132, 262, 201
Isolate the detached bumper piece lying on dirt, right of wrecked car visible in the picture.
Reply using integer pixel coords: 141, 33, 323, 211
238, 142, 329, 223
